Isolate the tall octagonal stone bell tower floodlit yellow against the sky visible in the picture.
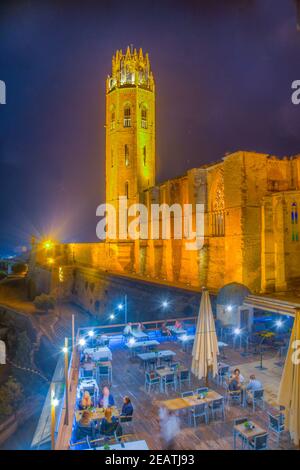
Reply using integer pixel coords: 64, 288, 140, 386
106, 47, 155, 237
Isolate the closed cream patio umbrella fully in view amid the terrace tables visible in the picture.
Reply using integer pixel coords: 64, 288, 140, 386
191, 289, 219, 379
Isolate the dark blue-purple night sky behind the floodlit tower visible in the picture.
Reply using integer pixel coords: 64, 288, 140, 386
0, 0, 300, 253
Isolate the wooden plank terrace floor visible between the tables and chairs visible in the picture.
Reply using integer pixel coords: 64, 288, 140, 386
106, 341, 295, 450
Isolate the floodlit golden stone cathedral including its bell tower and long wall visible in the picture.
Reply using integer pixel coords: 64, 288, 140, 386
37, 48, 300, 298
